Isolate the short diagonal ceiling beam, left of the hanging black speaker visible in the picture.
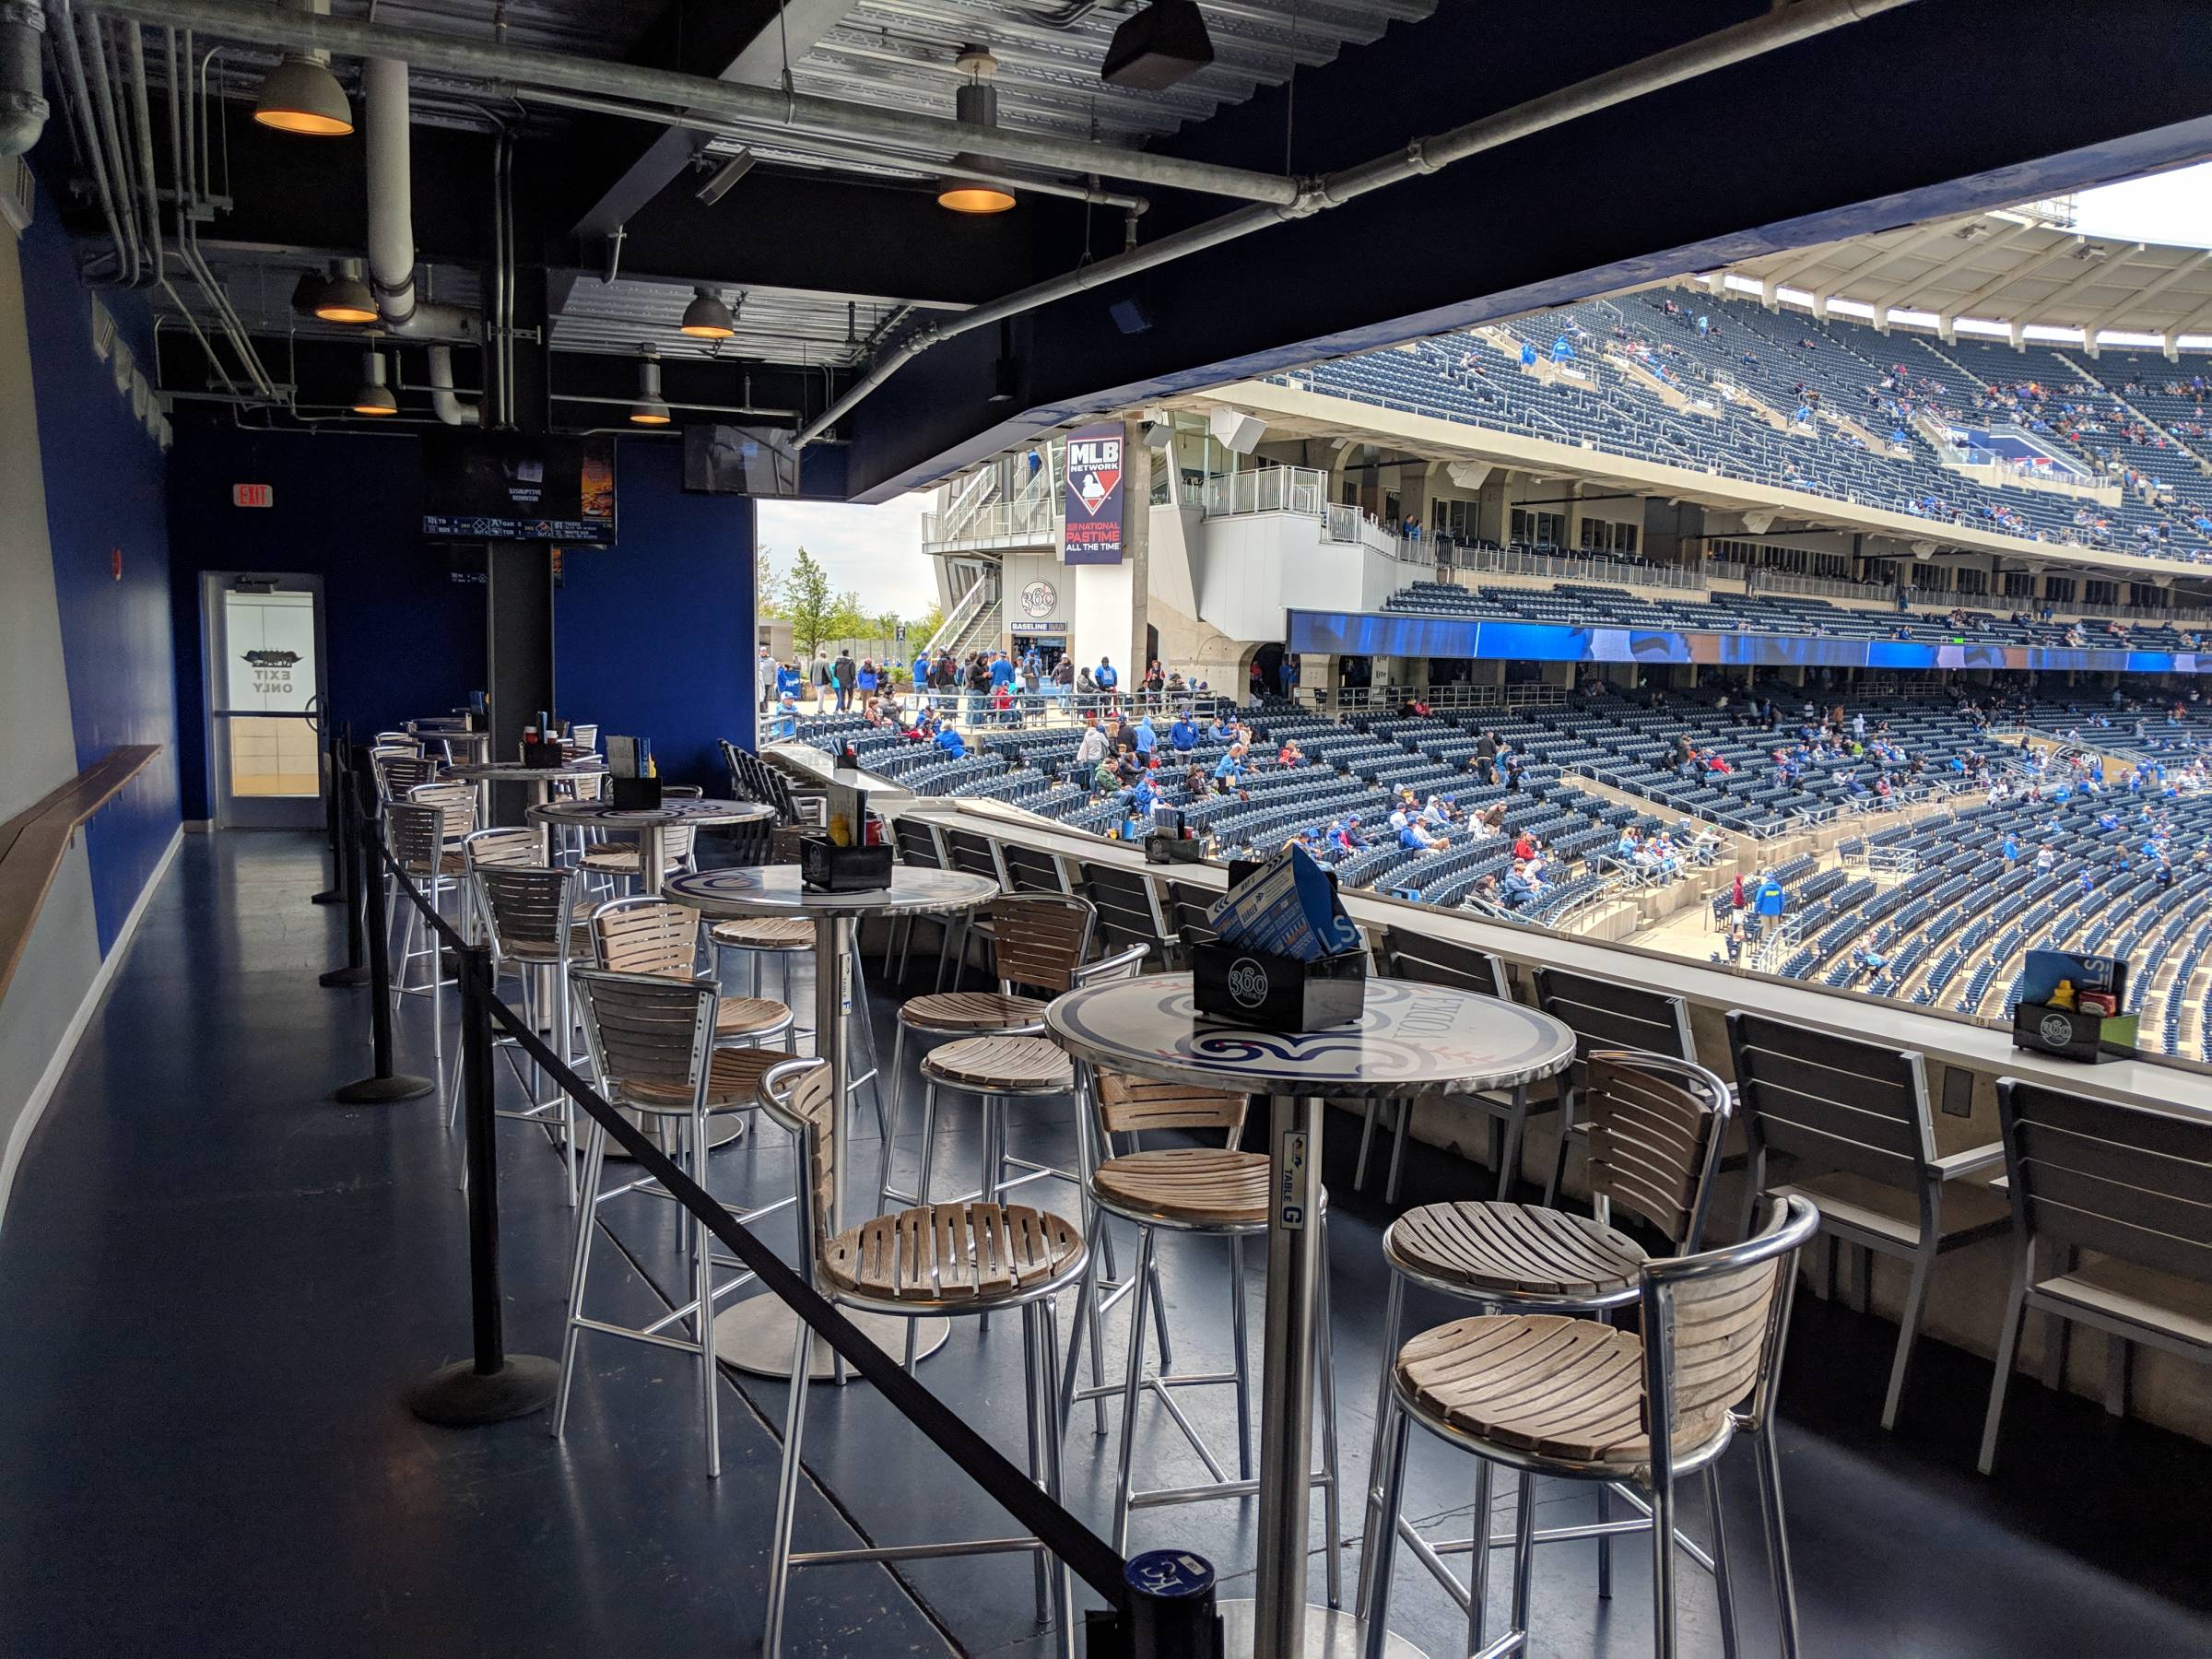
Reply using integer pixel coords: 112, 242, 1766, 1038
569, 0, 852, 241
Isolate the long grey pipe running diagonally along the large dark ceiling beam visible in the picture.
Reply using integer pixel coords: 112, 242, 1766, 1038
798, 0, 1912, 444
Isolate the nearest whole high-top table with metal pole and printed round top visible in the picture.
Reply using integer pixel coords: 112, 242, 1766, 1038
1044, 973, 1575, 1659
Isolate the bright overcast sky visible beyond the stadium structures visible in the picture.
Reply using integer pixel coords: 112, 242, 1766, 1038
761, 161, 2212, 618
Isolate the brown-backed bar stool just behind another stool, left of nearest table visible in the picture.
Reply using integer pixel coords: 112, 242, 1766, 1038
876, 894, 1097, 1215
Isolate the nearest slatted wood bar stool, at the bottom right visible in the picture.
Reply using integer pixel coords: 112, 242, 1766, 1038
1365, 1203, 1820, 1659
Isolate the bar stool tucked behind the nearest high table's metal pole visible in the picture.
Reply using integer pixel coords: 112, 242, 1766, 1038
1062, 1066, 1343, 1608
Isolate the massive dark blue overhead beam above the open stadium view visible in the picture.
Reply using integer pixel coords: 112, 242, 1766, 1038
842, 0, 2212, 500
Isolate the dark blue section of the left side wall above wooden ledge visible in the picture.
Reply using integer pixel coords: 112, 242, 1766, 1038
20, 201, 179, 956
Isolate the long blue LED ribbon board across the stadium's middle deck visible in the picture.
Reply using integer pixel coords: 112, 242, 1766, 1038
1288, 610, 2212, 675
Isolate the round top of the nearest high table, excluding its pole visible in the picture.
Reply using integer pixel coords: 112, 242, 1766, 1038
1044, 973, 1575, 1100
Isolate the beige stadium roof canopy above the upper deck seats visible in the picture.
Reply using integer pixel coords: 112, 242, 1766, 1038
1708, 204, 2212, 354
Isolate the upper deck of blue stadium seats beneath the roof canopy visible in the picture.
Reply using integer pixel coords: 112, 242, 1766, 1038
1274, 289, 2212, 564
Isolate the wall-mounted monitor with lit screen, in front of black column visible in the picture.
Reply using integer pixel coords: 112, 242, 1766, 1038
422, 431, 615, 547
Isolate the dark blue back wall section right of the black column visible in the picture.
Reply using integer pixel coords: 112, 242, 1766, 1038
553, 438, 754, 794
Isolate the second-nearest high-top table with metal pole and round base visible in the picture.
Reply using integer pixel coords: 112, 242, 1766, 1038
662, 865, 997, 1378
